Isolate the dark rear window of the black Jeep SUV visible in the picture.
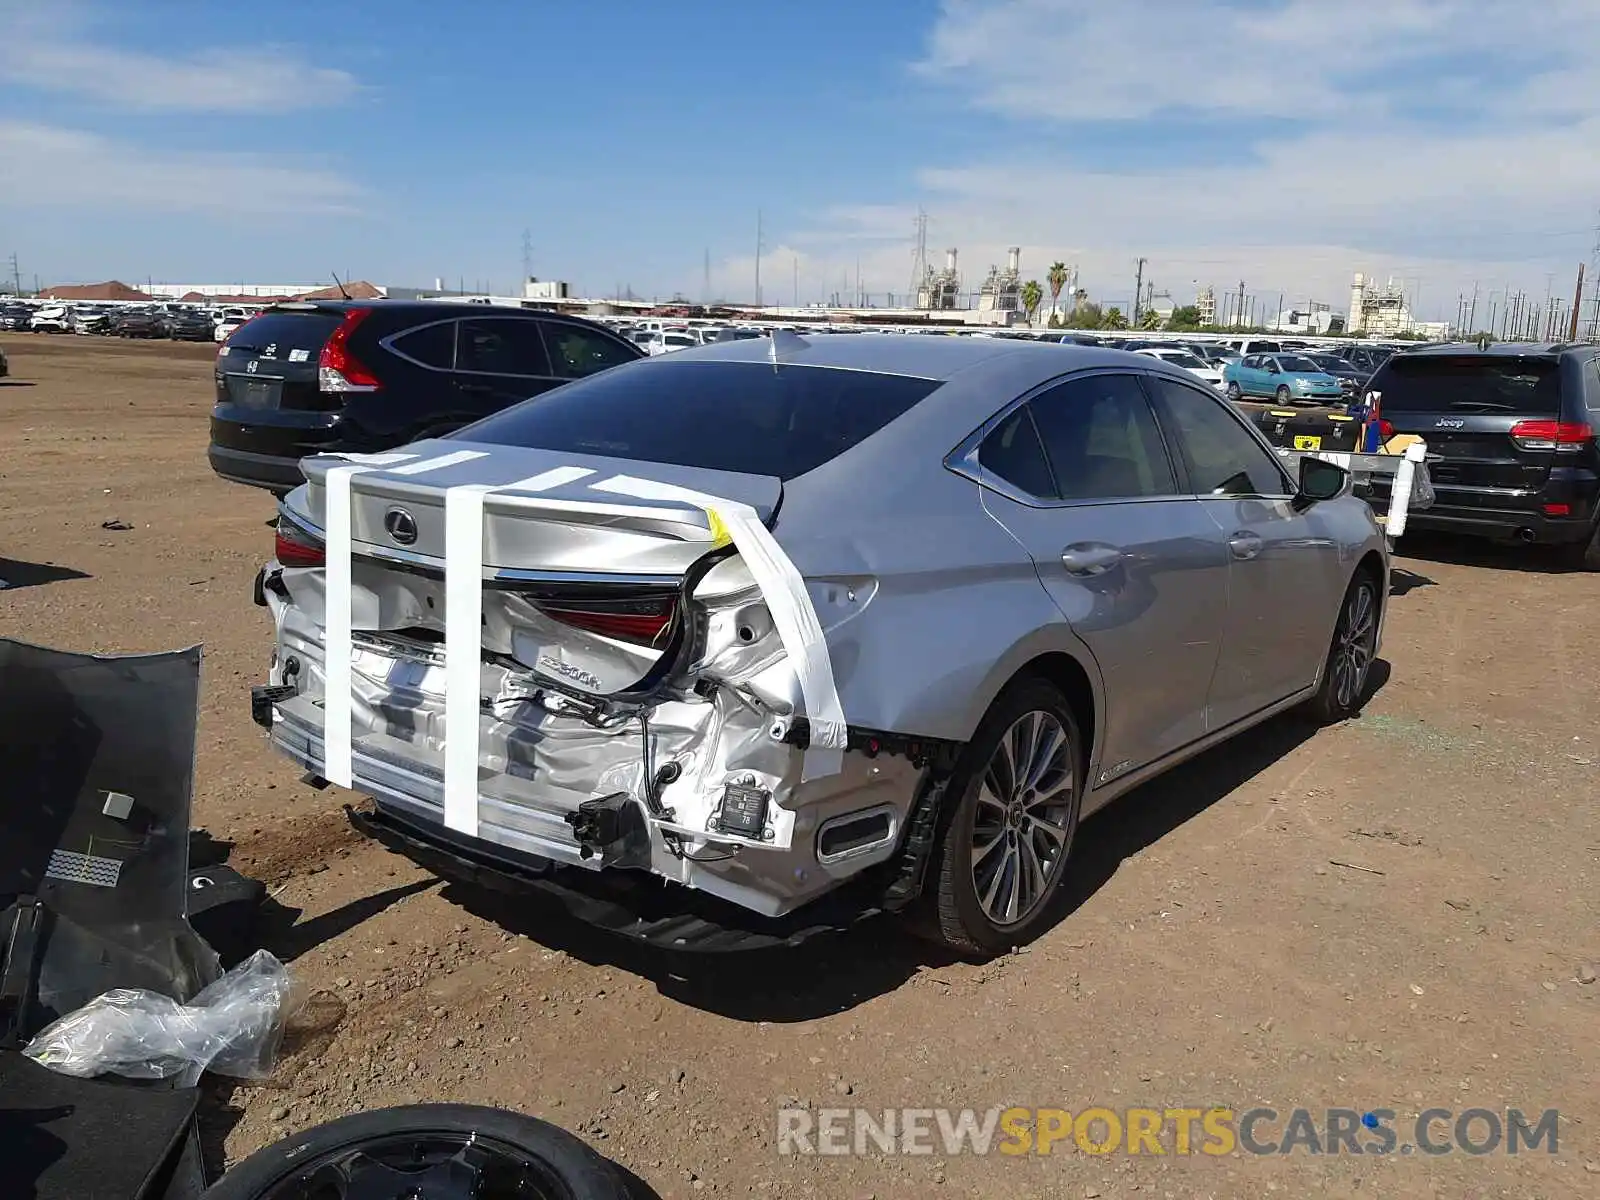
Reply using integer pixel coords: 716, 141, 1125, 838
1371, 355, 1562, 416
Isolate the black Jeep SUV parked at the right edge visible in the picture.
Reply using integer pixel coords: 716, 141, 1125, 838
1368, 342, 1600, 570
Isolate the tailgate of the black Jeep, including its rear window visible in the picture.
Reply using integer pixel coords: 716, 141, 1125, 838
1371, 354, 1562, 509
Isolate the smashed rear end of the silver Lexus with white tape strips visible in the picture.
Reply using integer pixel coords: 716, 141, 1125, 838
256, 440, 931, 918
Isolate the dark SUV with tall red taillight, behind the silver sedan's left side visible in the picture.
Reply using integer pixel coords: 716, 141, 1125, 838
210, 301, 645, 494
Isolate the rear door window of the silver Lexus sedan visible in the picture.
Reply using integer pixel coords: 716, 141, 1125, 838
1029, 374, 1178, 501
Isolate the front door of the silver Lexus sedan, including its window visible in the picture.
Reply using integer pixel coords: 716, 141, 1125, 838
1150, 376, 1344, 728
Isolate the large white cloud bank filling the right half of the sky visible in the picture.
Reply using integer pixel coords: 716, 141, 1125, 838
758, 0, 1600, 317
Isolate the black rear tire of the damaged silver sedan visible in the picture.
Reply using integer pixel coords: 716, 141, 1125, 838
925, 678, 1083, 958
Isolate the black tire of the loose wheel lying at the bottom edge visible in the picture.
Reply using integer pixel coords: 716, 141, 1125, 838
202, 1104, 629, 1200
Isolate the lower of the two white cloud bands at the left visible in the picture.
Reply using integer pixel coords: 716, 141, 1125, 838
0, 120, 362, 216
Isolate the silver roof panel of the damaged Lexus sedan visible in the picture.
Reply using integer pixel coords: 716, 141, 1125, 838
669, 333, 1139, 381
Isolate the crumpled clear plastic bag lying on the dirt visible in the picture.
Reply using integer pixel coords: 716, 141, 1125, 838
22, 950, 294, 1083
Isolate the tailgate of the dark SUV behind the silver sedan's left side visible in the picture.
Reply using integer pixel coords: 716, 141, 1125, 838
216, 309, 341, 422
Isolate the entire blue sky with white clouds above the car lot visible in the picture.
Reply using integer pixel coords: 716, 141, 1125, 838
9, 0, 1600, 324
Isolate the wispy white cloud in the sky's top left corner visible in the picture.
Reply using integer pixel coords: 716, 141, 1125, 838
0, 6, 357, 114
